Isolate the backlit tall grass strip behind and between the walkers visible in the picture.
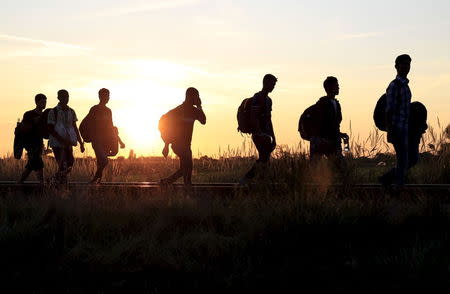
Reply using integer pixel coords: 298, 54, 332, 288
0, 124, 450, 183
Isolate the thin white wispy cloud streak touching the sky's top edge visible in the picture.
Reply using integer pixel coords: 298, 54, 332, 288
98, 0, 202, 16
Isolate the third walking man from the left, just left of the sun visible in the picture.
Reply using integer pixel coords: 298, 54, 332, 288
87, 88, 125, 183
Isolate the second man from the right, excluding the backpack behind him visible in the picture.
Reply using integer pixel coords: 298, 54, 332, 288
310, 77, 349, 161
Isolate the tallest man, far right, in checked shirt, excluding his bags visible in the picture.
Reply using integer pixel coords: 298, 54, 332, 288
380, 54, 411, 186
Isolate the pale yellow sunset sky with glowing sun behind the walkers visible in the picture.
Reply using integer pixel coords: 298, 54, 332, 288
0, 0, 450, 156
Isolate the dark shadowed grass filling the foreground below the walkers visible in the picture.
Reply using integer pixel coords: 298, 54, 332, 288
0, 188, 450, 293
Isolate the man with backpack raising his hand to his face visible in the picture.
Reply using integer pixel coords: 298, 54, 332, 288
159, 87, 206, 188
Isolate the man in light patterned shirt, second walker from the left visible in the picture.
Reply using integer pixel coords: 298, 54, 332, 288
47, 90, 84, 184
